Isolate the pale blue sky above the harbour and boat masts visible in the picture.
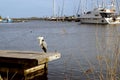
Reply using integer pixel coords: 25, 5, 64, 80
0, 0, 119, 18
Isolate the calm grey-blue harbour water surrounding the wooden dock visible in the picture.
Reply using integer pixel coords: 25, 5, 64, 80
0, 21, 120, 80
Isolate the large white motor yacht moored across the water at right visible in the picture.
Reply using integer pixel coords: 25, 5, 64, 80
80, 8, 120, 24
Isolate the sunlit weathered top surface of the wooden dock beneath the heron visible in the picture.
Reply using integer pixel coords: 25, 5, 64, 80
0, 50, 60, 61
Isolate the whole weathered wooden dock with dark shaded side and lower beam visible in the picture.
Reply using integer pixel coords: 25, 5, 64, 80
0, 50, 61, 79
